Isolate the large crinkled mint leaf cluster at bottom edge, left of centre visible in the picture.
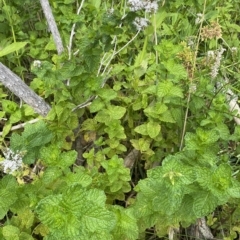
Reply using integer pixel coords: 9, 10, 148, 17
36, 185, 116, 239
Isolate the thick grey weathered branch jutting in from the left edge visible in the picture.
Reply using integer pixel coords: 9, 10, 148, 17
0, 63, 51, 117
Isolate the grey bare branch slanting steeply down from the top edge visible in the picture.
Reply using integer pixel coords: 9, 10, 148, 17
40, 0, 64, 55
